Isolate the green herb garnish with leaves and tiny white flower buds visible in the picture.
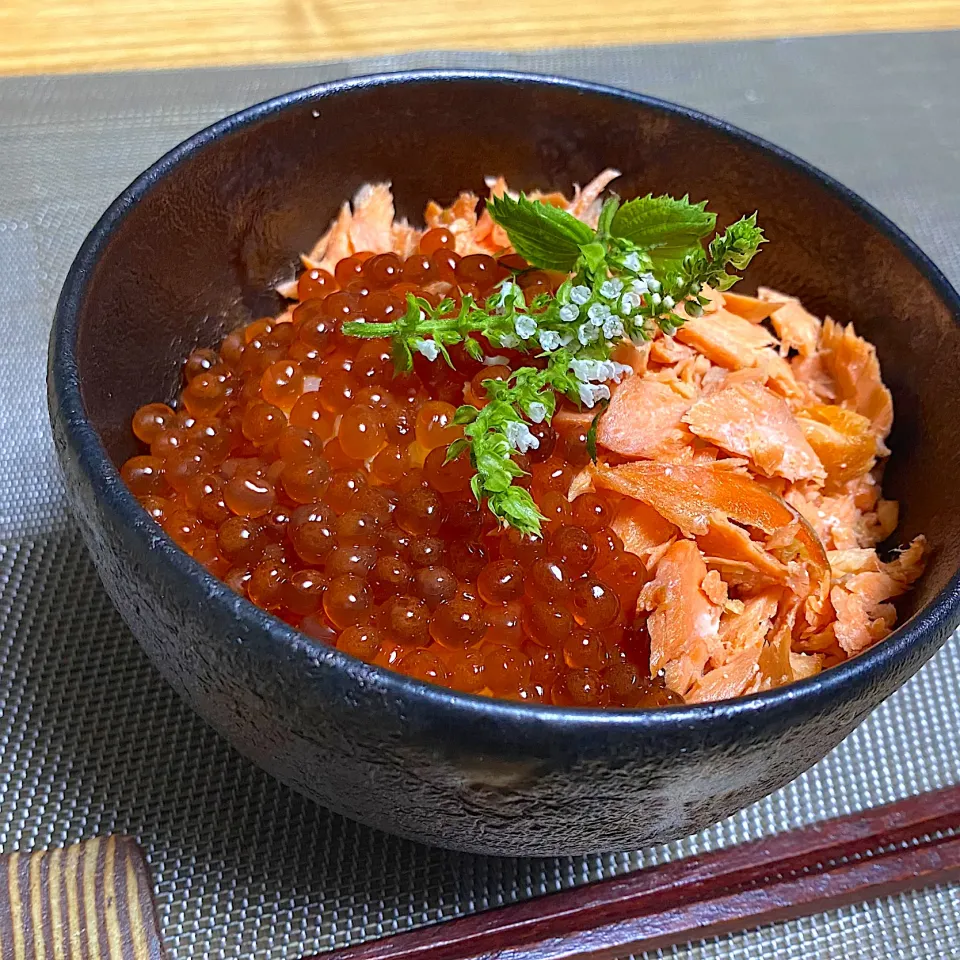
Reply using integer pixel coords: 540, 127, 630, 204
343, 195, 764, 535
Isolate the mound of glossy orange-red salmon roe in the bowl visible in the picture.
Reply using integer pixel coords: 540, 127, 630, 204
121, 251, 681, 708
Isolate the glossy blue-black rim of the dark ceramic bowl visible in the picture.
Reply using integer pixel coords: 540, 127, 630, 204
48, 69, 960, 735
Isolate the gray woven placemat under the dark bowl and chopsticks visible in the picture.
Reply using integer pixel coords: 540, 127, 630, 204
0, 33, 960, 960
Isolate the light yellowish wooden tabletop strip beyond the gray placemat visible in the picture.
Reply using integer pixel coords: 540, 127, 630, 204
0, 0, 960, 74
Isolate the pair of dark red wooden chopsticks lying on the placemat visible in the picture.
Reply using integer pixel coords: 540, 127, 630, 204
317, 785, 960, 960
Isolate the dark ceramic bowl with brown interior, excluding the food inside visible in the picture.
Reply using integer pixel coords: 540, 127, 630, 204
49, 72, 960, 854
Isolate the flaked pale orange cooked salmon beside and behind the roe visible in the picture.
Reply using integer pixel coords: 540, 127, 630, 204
277, 176, 929, 703
